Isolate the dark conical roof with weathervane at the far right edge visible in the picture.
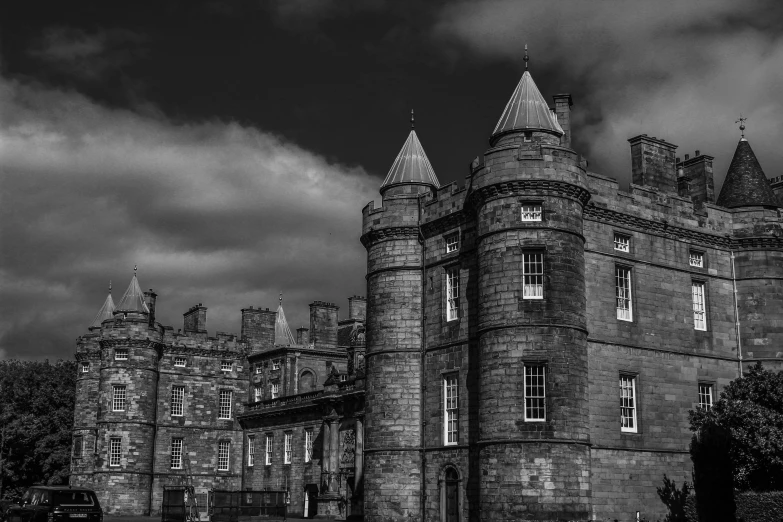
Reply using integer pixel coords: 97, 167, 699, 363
717, 138, 779, 208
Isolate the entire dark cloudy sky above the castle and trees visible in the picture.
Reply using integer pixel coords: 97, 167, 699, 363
0, 0, 783, 359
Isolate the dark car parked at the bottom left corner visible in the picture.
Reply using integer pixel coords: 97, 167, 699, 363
3, 486, 103, 522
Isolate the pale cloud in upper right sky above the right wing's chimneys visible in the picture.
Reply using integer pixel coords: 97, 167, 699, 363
434, 0, 783, 187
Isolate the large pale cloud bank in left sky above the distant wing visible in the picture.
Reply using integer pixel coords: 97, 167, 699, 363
0, 75, 379, 358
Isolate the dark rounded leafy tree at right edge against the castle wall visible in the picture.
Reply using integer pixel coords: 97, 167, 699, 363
690, 363, 783, 491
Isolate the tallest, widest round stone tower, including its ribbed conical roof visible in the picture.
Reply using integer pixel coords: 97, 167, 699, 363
469, 65, 591, 521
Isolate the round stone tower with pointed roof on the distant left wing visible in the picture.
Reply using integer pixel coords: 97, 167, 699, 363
96, 272, 162, 514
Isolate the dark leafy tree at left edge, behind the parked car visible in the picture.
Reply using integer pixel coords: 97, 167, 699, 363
0, 360, 76, 498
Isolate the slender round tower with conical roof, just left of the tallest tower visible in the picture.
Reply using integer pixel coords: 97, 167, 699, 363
361, 119, 439, 522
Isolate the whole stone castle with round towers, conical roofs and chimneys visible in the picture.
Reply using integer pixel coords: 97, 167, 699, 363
71, 62, 783, 522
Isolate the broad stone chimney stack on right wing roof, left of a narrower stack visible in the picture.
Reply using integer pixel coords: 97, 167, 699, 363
628, 134, 678, 194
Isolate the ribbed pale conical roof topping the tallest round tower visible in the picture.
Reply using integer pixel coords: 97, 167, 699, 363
490, 71, 564, 139
